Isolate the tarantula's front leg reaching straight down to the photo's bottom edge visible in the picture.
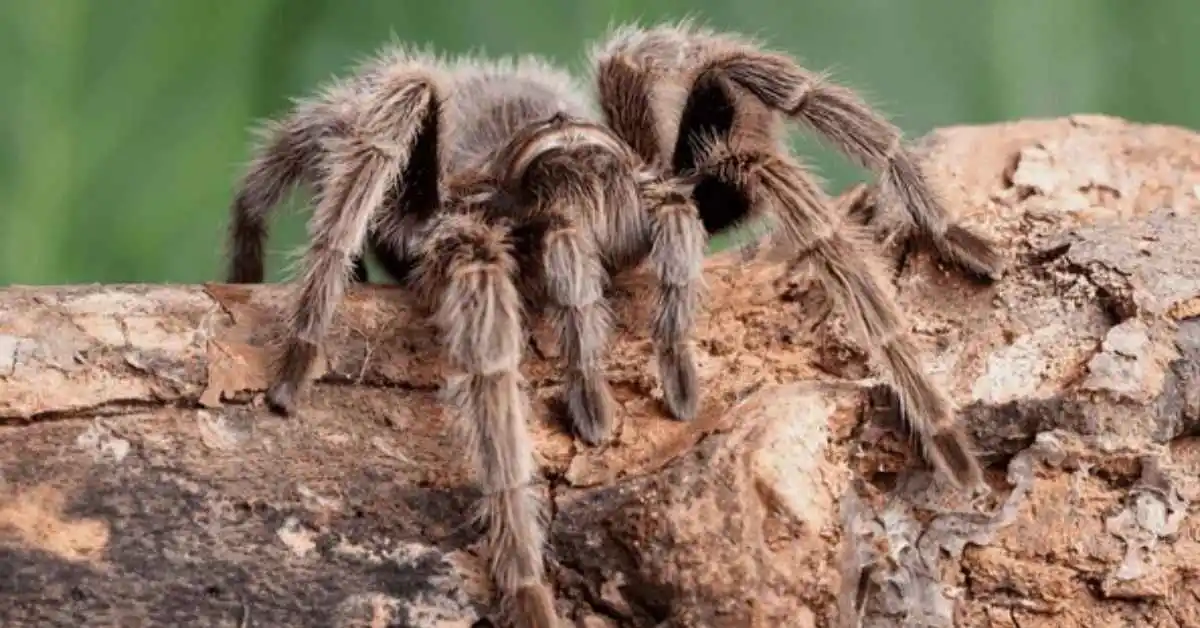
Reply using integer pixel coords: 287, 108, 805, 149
415, 209, 556, 628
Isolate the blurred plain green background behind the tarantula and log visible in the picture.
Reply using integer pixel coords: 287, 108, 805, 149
0, 0, 1200, 285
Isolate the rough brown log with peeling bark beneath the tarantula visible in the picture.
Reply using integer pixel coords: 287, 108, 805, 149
0, 116, 1200, 628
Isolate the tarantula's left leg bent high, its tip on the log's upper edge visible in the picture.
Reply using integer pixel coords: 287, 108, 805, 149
266, 64, 438, 414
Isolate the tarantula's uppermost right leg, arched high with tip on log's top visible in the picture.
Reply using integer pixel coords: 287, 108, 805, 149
593, 20, 1003, 281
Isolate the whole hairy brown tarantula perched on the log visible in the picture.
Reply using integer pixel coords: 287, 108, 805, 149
228, 23, 1001, 627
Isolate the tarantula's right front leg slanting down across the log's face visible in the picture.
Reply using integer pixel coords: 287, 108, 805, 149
698, 137, 982, 486
